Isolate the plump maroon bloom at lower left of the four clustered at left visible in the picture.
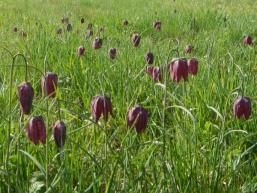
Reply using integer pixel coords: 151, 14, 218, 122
27, 116, 46, 145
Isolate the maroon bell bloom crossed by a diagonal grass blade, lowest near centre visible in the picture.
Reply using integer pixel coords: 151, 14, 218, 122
128, 105, 148, 133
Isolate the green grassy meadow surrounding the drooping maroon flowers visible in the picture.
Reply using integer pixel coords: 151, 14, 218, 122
0, 0, 257, 193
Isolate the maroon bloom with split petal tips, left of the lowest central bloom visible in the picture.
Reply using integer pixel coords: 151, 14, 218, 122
91, 95, 112, 122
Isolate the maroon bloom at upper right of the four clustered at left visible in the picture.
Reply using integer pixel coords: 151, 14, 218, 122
41, 72, 58, 97
